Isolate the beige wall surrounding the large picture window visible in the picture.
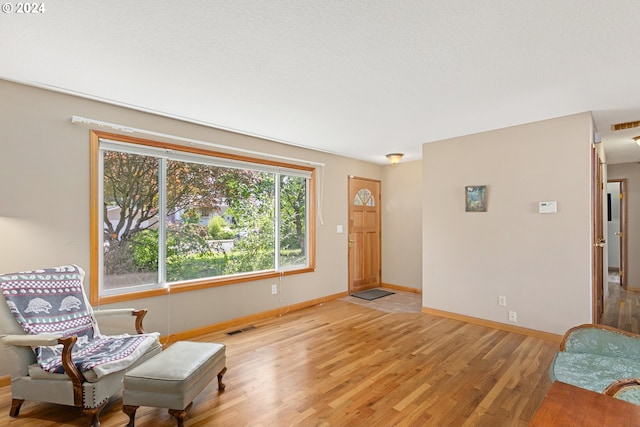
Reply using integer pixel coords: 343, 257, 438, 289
0, 80, 382, 342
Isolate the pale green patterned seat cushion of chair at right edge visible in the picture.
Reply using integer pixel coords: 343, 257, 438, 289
549, 351, 640, 393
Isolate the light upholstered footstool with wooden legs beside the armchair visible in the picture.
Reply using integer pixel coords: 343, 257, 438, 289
122, 341, 227, 427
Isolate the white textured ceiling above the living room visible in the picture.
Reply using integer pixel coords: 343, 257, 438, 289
0, 0, 640, 163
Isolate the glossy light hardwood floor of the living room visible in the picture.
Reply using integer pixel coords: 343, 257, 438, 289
0, 300, 558, 427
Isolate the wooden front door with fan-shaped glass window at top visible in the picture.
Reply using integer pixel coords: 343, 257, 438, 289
349, 176, 381, 293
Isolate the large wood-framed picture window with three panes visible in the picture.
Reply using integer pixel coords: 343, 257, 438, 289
92, 132, 313, 300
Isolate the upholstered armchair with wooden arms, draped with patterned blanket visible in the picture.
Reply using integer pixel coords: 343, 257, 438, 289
0, 266, 162, 427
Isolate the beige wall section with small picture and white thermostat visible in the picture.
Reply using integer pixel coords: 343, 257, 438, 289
422, 113, 592, 334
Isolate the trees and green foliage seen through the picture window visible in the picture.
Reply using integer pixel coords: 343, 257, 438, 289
102, 140, 308, 289
